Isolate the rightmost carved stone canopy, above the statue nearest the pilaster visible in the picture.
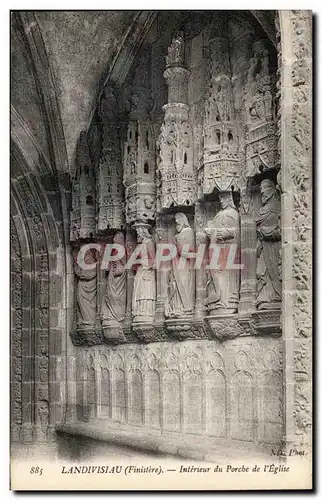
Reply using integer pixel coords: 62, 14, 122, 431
244, 40, 279, 177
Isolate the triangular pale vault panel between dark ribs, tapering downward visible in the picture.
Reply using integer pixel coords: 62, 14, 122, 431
36, 11, 135, 160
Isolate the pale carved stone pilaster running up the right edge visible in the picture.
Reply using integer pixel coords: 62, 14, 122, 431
279, 10, 312, 444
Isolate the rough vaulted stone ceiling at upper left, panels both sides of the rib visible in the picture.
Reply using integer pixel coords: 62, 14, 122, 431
11, 11, 138, 169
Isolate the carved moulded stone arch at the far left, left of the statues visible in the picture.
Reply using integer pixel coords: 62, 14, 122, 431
11, 140, 70, 442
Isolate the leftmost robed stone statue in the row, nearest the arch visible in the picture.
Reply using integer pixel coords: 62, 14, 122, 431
74, 247, 97, 329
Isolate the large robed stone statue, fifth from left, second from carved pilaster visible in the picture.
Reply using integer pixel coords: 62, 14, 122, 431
205, 191, 240, 314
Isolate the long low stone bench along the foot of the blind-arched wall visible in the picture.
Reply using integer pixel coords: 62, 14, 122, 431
56, 420, 276, 465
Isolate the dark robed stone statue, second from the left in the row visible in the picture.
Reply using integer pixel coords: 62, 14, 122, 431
101, 232, 126, 334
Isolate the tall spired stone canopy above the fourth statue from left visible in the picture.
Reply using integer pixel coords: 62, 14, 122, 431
158, 36, 196, 209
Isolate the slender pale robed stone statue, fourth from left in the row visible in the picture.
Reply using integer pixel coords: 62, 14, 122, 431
166, 213, 195, 317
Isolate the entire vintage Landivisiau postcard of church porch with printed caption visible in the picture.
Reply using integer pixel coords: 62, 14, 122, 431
10, 10, 312, 490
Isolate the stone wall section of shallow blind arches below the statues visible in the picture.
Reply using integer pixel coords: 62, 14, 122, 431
75, 337, 283, 444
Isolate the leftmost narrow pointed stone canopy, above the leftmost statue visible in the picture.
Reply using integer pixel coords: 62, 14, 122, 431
70, 132, 96, 242
